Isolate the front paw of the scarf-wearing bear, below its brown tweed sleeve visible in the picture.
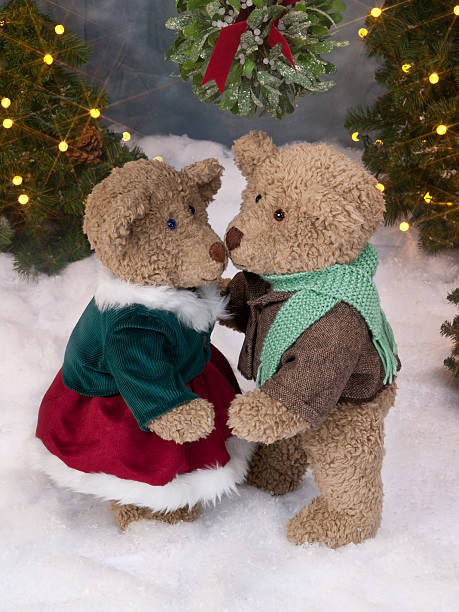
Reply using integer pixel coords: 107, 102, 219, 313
228, 389, 308, 444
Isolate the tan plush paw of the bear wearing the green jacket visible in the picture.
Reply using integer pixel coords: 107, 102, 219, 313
147, 397, 215, 444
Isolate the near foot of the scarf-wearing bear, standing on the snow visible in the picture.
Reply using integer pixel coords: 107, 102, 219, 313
286, 497, 379, 548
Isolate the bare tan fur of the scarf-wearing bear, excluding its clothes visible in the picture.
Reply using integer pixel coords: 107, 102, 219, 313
223, 132, 395, 548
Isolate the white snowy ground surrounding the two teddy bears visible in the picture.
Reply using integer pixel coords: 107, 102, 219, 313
0, 136, 459, 612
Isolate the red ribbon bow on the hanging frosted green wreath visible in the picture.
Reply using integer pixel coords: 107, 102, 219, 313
201, 0, 298, 93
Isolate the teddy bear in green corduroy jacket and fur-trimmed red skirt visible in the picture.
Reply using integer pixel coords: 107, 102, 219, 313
34, 158, 255, 529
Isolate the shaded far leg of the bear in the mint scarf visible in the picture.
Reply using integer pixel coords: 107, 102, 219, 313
246, 434, 308, 495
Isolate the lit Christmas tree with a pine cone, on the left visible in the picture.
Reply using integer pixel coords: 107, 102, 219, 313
0, 0, 143, 273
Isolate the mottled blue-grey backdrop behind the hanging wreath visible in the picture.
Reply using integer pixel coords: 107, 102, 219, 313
28, 0, 379, 145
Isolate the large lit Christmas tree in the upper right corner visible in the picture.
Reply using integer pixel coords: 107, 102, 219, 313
346, 0, 459, 252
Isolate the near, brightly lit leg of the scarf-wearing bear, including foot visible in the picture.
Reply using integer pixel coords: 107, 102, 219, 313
287, 387, 395, 548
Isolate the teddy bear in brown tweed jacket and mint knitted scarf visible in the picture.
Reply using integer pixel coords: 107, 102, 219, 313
225, 132, 400, 548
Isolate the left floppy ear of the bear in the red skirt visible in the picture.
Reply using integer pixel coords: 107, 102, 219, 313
83, 184, 151, 255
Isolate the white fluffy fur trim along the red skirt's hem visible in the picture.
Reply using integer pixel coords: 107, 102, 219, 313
30, 436, 256, 512
